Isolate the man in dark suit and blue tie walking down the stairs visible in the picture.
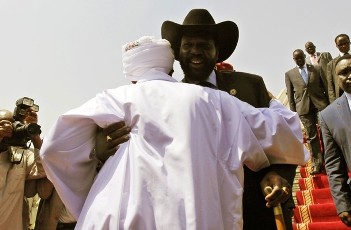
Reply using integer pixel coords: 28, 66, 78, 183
285, 49, 329, 175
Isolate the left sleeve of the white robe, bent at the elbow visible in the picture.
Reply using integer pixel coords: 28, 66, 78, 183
40, 90, 123, 218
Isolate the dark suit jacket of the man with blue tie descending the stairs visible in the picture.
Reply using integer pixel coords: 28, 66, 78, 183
285, 65, 329, 115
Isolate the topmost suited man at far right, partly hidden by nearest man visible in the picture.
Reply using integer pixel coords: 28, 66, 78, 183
327, 34, 350, 103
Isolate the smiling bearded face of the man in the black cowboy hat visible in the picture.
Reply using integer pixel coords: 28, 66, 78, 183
179, 35, 218, 82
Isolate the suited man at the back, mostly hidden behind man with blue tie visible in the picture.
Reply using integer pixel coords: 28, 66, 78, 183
305, 42, 333, 89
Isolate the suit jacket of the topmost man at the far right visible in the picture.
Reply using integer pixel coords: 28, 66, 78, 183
327, 55, 341, 103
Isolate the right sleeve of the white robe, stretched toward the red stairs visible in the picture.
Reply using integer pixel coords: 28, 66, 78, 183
232, 97, 310, 165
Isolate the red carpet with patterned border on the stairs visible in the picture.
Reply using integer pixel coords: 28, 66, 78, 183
293, 159, 351, 230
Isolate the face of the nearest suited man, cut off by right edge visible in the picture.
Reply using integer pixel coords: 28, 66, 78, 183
335, 58, 351, 93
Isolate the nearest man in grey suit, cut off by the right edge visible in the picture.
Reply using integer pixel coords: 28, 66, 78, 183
320, 54, 351, 227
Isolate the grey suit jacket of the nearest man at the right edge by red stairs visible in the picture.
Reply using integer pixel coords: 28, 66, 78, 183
320, 95, 351, 213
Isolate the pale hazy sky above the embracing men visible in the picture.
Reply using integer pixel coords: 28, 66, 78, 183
0, 0, 351, 136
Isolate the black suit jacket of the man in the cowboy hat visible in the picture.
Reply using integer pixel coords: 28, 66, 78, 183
216, 72, 296, 230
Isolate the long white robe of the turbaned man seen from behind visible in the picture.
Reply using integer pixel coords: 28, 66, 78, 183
41, 72, 307, 230
